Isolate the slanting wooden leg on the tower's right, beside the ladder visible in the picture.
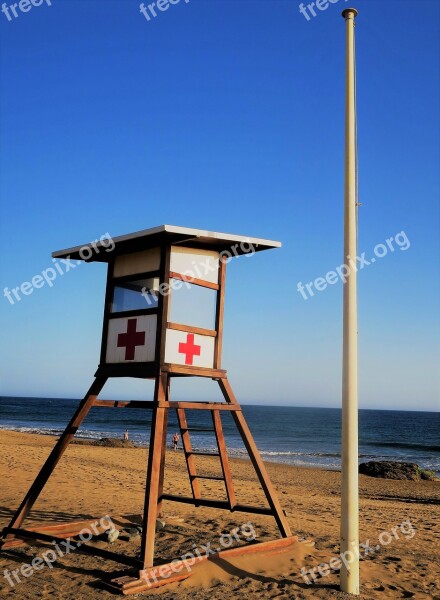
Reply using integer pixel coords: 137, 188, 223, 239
218, 379, 292, 537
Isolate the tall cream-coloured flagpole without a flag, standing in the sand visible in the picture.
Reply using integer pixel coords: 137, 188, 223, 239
340, 8, 359, 594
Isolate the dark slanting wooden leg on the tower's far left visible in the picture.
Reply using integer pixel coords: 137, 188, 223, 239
3, 377, 107, 538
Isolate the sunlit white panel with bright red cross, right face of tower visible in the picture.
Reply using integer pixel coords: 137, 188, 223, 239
165, 329, 215, 369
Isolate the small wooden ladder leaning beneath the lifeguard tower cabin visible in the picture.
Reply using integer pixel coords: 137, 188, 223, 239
176, 408, 237, 510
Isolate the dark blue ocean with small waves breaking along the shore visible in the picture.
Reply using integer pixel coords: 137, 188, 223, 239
0, 396, 440, 474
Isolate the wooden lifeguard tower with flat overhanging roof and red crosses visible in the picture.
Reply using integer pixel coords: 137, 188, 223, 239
2, 225, 297, 594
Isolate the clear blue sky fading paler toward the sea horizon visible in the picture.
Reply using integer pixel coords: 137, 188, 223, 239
0, 0, 440, 410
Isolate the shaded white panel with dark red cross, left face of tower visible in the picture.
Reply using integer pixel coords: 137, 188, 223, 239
106, 315, 157, 363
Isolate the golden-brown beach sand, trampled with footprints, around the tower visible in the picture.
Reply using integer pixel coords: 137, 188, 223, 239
0, 430, 440, 600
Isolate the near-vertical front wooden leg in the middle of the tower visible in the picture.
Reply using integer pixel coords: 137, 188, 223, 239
141, 373, 169, 569
